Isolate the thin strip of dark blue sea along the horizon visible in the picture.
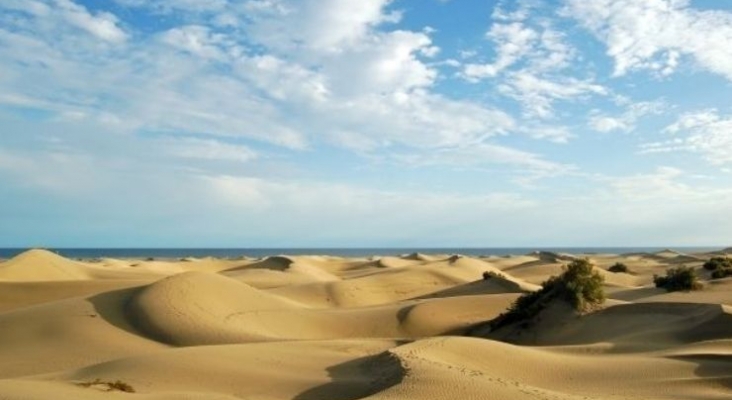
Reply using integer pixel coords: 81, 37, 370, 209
0, 247, 722, 259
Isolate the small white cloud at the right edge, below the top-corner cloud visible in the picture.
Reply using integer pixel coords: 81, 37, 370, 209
641, 109, 732, 166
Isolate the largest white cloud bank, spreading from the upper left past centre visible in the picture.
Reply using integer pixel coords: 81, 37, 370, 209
0, 0, 528, 156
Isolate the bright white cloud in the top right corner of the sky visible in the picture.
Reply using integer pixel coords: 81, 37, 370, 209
564, 0, 732, 80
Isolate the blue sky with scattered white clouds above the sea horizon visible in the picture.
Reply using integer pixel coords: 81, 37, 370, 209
0, 0, 732, 247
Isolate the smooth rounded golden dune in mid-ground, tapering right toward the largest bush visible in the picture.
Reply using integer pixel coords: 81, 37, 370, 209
129, 272, 516, 346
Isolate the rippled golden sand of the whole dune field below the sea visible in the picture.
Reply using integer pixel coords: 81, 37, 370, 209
0, 250, 732, 400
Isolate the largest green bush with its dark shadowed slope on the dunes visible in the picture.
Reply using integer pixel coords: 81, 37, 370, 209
490, 259, 605, 330
